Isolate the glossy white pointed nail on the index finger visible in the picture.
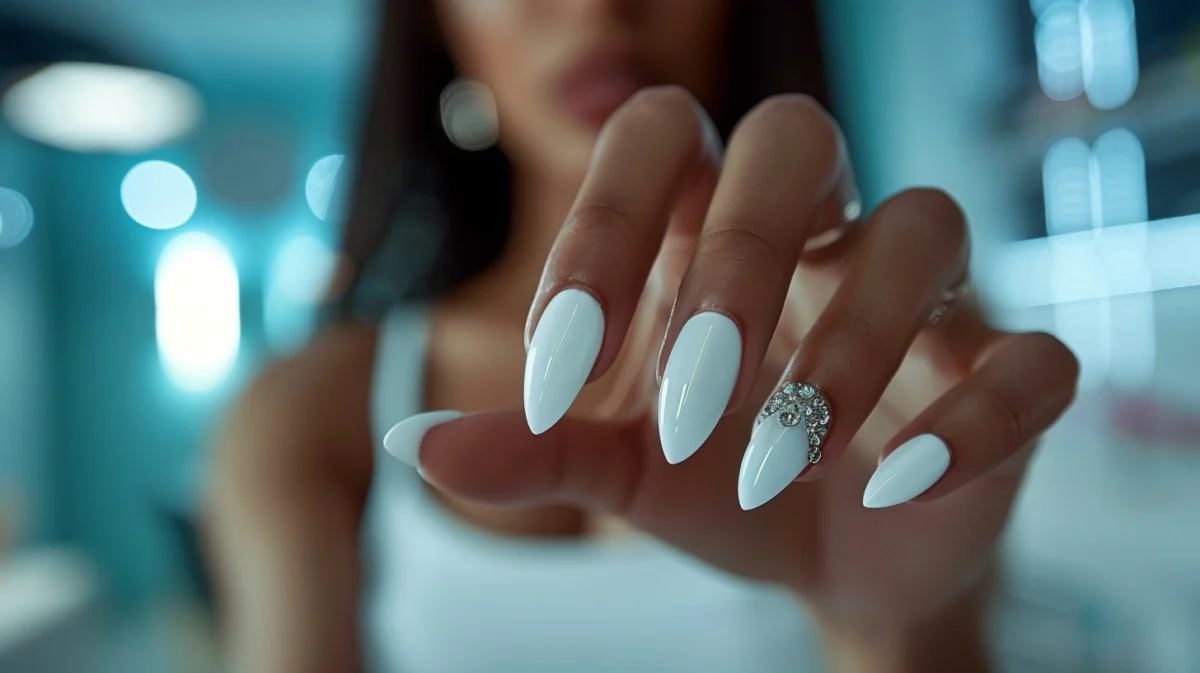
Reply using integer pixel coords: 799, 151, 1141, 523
524, 288, 604, 434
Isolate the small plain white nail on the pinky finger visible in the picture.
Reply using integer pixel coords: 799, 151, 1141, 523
863, 434, 950, 509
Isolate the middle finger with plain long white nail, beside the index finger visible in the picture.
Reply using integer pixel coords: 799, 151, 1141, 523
658, 95, 853, 463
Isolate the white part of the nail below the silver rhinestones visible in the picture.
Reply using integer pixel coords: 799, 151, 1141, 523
738, 416, 811, 510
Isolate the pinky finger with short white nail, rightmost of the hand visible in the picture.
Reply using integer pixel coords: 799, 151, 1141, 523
863, 334, 1079, 507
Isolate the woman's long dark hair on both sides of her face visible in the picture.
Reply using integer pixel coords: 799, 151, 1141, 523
338, 0, 828, 316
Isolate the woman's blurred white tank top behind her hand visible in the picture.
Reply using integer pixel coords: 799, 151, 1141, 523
364, 308, 822, 673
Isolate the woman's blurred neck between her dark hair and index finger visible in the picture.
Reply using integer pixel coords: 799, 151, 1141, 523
453, 169, 578, 319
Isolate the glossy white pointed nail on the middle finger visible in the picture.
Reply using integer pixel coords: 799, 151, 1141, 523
659, 312, 742, 464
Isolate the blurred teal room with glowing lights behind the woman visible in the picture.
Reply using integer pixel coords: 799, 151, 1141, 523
0, 0, 1200, 673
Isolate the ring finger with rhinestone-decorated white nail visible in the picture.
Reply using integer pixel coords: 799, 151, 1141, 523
738, 190, 968, 510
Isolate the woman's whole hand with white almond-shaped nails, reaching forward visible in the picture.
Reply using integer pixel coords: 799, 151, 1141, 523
394, 88, 1076, 667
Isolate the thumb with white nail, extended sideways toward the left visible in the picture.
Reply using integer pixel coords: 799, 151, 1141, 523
384, 410, 654, 513
